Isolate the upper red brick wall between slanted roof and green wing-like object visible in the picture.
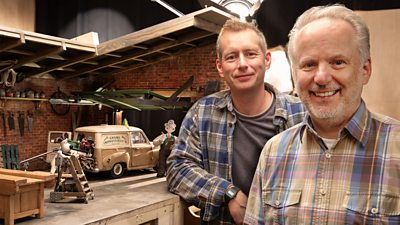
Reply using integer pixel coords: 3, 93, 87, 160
114, 45, 225, 93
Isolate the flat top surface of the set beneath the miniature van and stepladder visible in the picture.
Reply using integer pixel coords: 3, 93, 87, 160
0, 170, 179, 225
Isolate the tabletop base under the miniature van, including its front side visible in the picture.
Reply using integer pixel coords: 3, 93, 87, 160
0, 173, 183, 225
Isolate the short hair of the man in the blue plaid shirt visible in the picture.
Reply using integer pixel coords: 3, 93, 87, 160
216, 18, 267, 59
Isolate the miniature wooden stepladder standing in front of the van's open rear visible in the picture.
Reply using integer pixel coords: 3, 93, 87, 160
50, 151, 94, 203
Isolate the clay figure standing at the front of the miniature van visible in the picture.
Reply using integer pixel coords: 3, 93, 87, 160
153, 120, 176, 177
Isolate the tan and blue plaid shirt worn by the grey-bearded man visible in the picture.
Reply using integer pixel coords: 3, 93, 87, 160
245, 102, 400, 225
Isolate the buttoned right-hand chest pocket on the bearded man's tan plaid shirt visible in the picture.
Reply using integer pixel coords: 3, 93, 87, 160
343, 192, 400, 224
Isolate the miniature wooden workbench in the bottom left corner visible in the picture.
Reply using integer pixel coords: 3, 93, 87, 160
0, 169, 55, 225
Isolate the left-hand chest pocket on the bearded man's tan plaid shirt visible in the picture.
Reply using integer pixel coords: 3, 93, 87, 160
263, 189, 301, 224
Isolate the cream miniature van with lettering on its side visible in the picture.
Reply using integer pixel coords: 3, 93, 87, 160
72, 125, 160, 178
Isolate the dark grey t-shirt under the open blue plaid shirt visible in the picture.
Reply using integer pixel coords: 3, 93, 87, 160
232, 96, 276, 196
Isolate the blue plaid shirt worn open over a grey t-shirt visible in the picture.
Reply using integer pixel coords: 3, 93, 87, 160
167, 85, 305, 224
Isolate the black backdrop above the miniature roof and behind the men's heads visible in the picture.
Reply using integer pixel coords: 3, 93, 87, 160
36, 0, 400, 47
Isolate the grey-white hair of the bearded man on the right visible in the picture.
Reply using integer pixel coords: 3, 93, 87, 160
288, 4, 370, 65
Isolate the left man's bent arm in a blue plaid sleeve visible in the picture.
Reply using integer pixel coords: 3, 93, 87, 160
167, 105, 231, 221
